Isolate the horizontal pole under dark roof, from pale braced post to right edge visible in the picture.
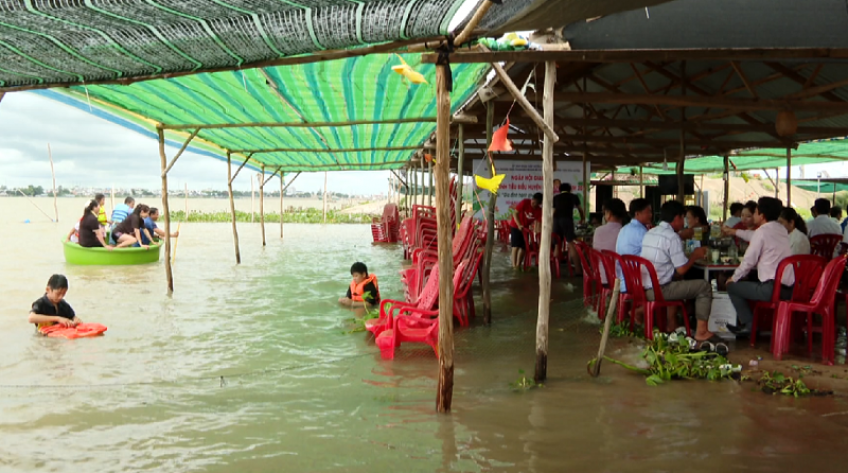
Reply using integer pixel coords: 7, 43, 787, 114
536, 92, 848, 113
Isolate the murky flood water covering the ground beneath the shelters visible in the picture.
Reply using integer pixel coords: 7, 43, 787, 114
0, 199, 848, 473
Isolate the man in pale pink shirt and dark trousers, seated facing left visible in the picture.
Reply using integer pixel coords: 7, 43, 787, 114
727, 197, 796, 335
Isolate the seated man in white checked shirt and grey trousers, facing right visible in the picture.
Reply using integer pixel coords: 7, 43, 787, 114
642, 200, 712, 341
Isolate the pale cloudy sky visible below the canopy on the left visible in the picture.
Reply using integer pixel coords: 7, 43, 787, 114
0, 92, 389, 194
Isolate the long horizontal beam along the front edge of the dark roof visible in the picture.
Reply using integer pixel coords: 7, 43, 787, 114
421, 48, 848, 64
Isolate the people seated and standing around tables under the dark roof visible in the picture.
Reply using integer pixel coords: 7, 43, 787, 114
509, 184, 848, 341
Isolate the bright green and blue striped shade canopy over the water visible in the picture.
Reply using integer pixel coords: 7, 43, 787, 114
32, 54, 489, 172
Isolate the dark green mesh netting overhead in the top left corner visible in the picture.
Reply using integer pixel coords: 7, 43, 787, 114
0, 0, 470, 87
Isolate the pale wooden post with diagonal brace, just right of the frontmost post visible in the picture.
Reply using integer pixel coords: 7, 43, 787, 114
533, 61, 556, 383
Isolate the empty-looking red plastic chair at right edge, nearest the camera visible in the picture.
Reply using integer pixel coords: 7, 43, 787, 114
772, 256, 845, 365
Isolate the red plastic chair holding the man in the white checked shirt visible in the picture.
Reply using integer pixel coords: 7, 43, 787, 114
621, 255, 691, 340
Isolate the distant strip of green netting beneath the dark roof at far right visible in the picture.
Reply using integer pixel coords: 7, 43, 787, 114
619, 139, 848, 175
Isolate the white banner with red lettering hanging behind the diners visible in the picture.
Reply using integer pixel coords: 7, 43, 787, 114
474, 159, 592, 219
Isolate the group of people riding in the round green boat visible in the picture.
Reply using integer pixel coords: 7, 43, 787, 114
66, 194, 179, 250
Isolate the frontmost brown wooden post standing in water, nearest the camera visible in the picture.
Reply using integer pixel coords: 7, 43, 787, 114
438, 65, 454, 412
